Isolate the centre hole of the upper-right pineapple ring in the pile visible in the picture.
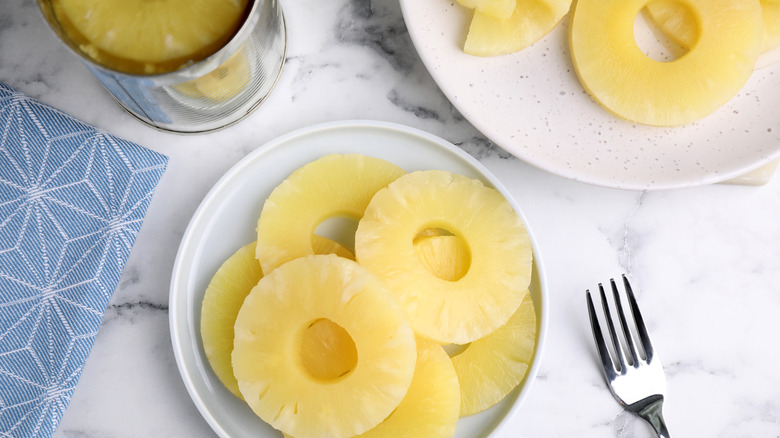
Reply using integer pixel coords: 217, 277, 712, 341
413, 227, 471, 281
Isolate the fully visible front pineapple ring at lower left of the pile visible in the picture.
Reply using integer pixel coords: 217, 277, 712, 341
232, 255, 417, 438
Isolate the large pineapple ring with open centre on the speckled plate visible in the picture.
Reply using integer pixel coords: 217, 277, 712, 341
570, 0, 762, 126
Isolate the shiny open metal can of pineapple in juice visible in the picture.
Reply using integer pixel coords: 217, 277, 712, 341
37, 0, 287, 133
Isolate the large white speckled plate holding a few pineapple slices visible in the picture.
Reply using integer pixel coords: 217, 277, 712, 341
401, 0, 780, 190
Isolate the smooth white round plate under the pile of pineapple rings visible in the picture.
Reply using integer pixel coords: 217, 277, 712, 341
169, 121, 548, 438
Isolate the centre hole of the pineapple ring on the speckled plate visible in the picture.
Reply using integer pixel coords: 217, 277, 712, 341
634, 0, 700, 62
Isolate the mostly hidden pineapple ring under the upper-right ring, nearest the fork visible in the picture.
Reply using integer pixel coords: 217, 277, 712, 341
415, 236, 536, 416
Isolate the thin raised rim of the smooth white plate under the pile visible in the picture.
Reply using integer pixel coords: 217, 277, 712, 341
168, 119, 549, 437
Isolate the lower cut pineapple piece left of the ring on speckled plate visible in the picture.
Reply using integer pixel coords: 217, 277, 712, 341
463, 0, 571, 56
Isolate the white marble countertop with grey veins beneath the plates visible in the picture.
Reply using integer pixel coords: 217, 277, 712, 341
0, 0, 780, 437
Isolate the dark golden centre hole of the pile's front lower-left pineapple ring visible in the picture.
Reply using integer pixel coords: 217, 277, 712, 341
300, 318, 357, 381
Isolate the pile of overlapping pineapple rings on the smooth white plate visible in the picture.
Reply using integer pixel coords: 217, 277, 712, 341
201, 154, 536, 438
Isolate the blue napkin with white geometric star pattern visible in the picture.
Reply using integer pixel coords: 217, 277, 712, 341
0, 83, 167, 437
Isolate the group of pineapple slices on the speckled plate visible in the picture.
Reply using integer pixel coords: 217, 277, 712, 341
458, 0, 780, 126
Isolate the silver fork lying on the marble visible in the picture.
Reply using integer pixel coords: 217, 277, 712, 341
585, 275, 669, 438
